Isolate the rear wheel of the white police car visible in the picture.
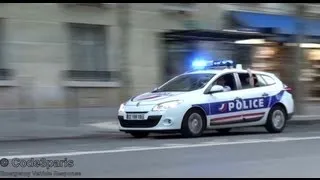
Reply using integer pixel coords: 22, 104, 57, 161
265, 106, 288, 133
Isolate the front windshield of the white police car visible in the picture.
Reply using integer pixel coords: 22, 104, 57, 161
153, 73, 215, 92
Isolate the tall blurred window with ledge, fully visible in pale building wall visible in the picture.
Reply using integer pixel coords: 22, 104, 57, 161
69, 23, 113, 81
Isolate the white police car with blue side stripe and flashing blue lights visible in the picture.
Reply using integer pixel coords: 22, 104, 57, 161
118, 60, 294, 138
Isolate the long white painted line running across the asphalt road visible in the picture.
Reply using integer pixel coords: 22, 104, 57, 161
0, 136, 320, 159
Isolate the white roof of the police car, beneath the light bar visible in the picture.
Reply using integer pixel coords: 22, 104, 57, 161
184, 68, 274, 76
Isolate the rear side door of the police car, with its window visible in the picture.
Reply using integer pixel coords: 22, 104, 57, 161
236, 72, 273, 122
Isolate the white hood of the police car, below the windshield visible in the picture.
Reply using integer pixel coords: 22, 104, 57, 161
126, 92, 187, 106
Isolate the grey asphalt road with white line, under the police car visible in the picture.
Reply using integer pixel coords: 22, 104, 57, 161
0, 124, 320, 178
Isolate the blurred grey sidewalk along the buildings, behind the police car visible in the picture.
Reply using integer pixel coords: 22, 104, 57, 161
0, 106, 320, 141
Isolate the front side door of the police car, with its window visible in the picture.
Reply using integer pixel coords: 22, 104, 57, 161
206, 73, 242, 127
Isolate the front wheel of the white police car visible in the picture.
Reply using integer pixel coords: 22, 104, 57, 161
181, 109, 206, 138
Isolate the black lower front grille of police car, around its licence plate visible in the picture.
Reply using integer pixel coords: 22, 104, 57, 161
118, 116, 161, 128
